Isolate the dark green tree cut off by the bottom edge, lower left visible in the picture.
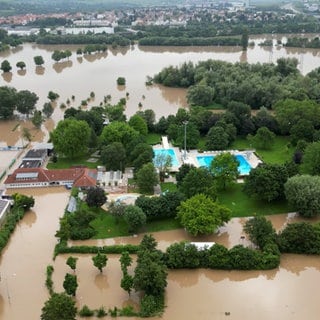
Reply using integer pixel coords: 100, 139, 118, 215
41, 293, 77, 320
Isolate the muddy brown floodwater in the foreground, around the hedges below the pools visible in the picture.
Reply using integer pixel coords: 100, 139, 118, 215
0, 188, 320, 320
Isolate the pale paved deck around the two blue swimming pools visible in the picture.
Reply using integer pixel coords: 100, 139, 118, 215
153, 141, 262, 172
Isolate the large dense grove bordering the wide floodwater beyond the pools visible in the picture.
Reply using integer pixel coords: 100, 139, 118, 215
154, 58, 319, 109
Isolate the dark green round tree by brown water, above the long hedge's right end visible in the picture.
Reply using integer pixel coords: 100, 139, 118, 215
243, 216, 276, 250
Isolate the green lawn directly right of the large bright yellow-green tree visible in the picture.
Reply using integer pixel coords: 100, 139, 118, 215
218, 184, 290, 217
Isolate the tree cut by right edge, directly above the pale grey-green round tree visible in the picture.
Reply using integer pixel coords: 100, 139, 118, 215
301, 141, 320, 175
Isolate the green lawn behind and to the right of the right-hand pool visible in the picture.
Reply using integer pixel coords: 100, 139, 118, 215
231, 136, 294, 163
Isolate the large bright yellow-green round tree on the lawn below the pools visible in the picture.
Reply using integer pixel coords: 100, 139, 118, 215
177, 194, 231, 236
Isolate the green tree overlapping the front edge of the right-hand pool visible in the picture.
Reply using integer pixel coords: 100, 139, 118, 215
210, 152, 239, 190
